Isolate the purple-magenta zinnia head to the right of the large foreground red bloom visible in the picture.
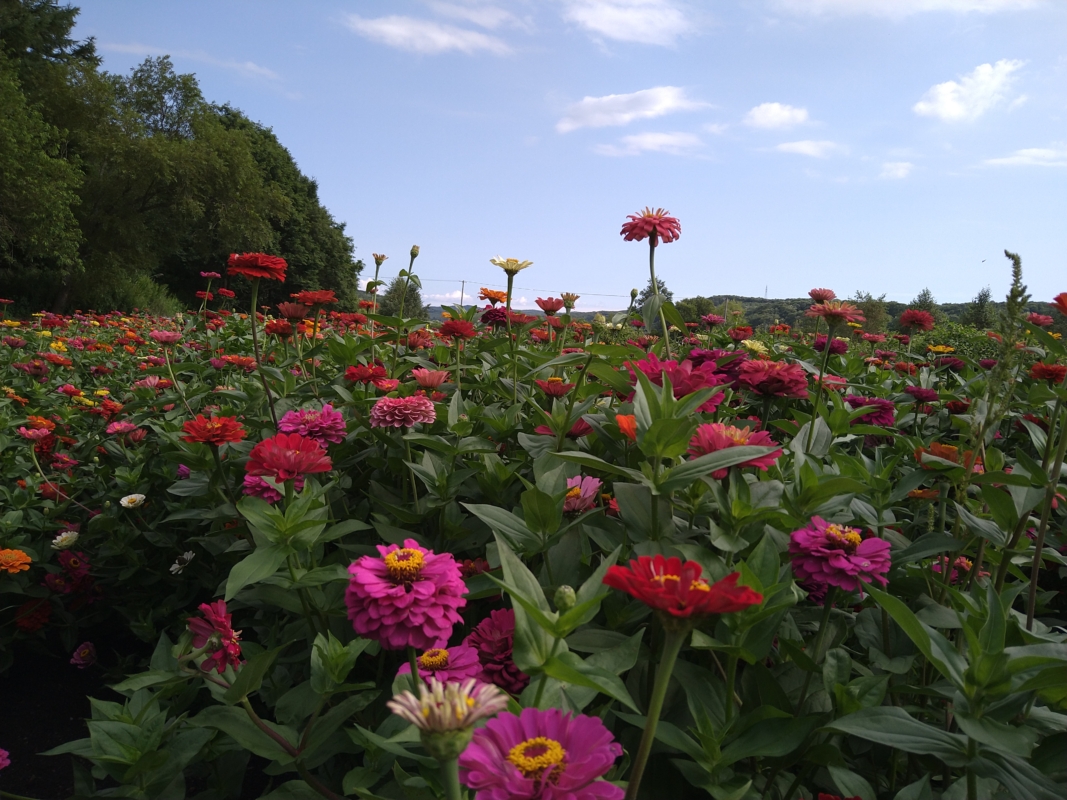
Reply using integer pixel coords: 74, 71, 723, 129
790, 516, 890, 594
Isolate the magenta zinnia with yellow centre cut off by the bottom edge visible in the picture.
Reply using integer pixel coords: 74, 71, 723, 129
460, 708, 624, 800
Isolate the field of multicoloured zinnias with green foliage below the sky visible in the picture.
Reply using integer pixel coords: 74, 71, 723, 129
0, 214, 1067, 800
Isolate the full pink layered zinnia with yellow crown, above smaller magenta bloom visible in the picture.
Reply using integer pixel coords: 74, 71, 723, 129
345, 539, 466, 651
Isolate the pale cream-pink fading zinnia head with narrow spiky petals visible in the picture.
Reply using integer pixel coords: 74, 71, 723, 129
385, 677, 508, 733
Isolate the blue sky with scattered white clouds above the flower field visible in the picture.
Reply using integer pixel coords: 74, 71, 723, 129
77, 0, 1067, 309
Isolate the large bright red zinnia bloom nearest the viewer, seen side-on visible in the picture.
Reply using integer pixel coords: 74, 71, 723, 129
604, 555, 763, 619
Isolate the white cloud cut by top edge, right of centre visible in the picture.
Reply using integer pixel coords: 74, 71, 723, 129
563, 0, 692, 45
